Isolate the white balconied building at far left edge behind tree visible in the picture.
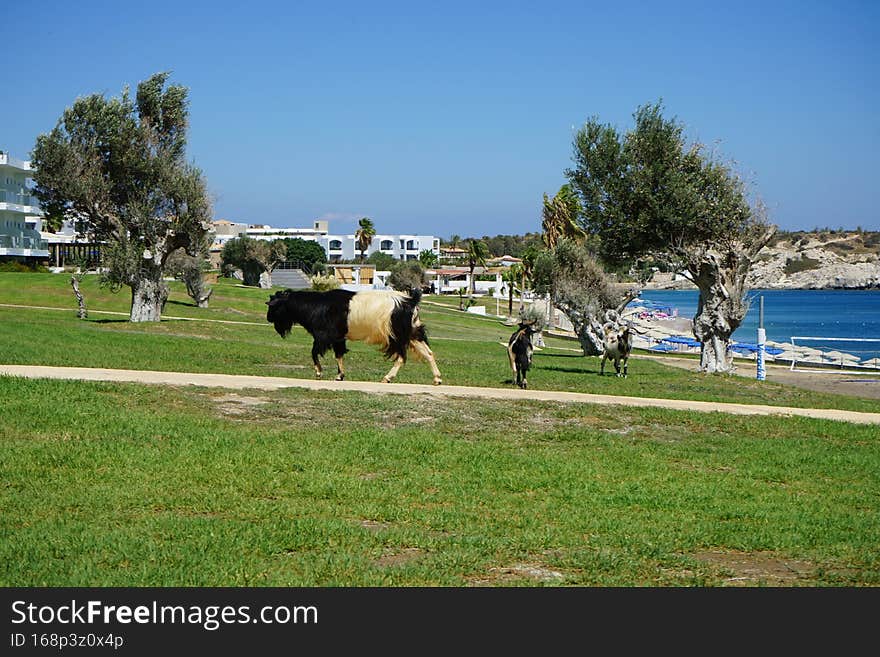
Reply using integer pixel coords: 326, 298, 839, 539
0, 152, 49, 260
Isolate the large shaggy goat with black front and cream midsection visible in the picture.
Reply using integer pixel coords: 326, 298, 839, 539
266, 290, 441, 385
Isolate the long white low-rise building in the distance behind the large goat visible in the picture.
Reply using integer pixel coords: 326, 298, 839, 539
212, 220, 440, 262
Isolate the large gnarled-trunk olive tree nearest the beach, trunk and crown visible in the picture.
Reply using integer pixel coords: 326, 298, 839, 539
566, 103, 775, 372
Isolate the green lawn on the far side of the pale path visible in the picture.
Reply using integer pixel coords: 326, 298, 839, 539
0, 274, 877, 412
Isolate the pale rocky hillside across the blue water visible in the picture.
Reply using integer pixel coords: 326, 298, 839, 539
749, 231, 880, 289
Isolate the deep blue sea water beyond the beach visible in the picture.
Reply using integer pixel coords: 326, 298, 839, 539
636, 290, 880, 358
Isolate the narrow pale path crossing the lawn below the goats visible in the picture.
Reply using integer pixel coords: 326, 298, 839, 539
0, 359, 880, 424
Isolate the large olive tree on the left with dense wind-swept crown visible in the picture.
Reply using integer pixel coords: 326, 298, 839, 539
31, 73, 211, 322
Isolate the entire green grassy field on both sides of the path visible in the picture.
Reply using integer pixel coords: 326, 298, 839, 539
0, 274, 880, 587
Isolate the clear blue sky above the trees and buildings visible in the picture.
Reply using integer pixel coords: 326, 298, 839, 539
0, 0, 880, 237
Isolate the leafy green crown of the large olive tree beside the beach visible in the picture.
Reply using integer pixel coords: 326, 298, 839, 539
566, 103, 768, 263
